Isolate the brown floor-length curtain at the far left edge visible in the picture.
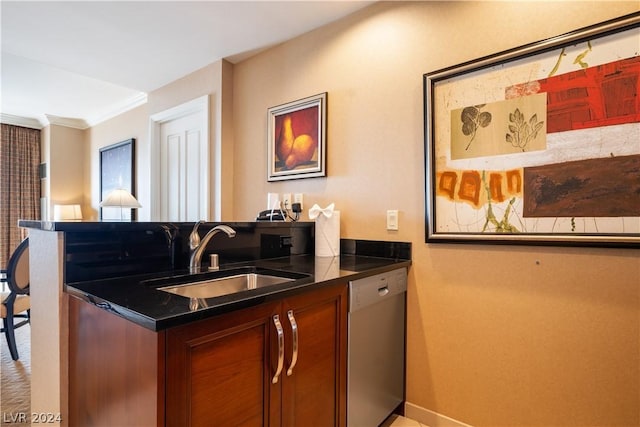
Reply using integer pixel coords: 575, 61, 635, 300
0, 123, 40, 270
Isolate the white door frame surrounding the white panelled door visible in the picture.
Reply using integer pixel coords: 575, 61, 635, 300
149, 95, 211, 221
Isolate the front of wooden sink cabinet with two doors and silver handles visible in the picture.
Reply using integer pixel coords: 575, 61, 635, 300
166, 285, 347, 426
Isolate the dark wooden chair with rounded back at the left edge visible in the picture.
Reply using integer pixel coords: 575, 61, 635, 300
0, 238, 31, 360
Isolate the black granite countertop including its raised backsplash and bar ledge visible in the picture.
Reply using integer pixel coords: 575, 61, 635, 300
19, 220, 411, 331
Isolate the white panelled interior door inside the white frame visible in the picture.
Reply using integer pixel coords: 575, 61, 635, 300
158, 112, 208, 221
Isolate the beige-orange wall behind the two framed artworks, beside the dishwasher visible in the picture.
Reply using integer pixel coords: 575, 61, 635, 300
233, 1, 640, 426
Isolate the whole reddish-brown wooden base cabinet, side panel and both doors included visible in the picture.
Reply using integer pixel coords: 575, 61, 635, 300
69, 284, 347, 427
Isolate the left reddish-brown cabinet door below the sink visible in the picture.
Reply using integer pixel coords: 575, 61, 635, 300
166, 303, 281, 426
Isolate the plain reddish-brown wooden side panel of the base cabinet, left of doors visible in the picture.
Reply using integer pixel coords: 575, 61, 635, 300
64, 297, 165, 427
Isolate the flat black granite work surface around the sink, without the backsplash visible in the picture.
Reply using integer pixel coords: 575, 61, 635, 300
65, 255, 411, 331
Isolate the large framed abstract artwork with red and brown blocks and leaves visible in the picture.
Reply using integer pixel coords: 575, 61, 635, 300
423, 13, 640, 247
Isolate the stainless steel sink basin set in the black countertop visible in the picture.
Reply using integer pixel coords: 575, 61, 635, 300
157, 273, 296, 298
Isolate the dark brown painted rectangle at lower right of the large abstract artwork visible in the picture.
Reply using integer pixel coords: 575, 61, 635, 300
523, 154, 640, 217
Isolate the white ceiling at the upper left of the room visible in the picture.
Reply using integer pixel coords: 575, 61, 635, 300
0, 0, 373, 127
